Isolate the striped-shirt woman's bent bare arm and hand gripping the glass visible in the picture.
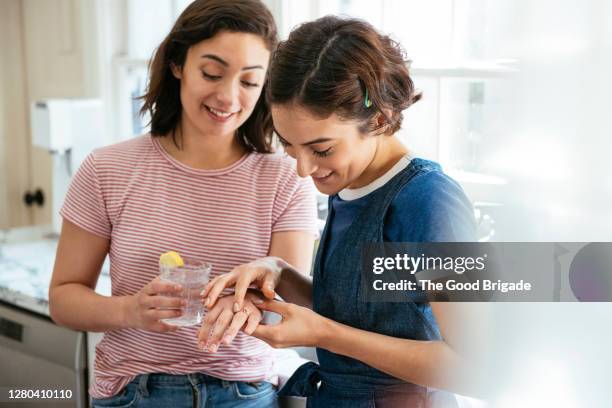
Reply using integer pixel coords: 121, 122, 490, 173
49, 221, 181, 332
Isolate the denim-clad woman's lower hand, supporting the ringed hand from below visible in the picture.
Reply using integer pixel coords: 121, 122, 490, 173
253, 300, 331, 348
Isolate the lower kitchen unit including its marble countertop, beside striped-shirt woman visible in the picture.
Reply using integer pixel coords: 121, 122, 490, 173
0, 227, 111, 407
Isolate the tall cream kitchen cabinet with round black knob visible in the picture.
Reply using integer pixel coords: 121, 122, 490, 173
0, 0, 99, 229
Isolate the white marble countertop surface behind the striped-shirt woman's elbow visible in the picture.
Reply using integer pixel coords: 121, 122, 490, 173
0, 227, 111, 316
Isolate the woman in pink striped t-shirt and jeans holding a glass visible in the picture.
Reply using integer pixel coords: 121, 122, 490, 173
49, 0, 316, 407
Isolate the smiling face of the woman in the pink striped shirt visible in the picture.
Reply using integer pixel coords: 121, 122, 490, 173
172, 31, 270, 136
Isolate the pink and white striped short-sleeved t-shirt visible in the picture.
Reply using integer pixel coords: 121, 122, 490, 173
61, 135, 317, 398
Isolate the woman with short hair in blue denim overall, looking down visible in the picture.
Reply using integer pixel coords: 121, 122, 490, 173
200, 16, 475, 408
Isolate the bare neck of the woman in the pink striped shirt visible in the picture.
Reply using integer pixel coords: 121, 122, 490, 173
161, 120, 246, 170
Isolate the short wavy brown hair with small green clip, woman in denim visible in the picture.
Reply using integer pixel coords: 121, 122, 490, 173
266, 16, 421, 134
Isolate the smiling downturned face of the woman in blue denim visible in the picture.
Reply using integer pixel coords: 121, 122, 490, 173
271, 105, 379, 195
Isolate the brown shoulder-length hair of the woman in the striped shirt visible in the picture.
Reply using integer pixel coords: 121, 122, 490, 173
140, 0, 278, 153
